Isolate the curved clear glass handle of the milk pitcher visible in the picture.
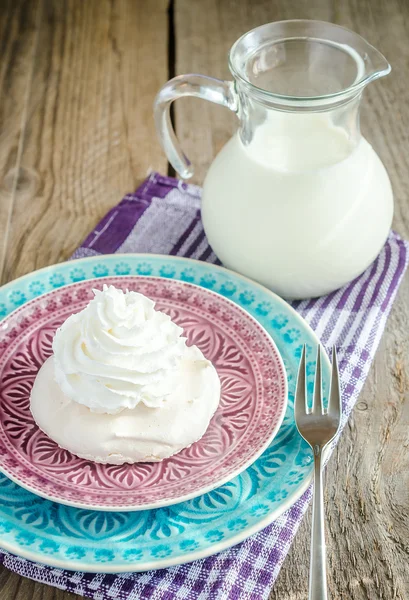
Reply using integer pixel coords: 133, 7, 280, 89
154, 74, 238, 179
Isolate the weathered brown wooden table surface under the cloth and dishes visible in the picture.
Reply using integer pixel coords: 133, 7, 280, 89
0, 0, 409, 600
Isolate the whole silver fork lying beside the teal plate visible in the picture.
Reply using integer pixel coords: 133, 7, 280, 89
294, 346, 341, 600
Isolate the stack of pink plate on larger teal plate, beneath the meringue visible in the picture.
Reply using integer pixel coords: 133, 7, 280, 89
0, 254, 330, 573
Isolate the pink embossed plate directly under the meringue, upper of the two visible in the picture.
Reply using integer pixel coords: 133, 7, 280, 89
0, 276, 287, 511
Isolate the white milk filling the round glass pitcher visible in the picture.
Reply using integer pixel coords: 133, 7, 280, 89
202, 111, 393, 298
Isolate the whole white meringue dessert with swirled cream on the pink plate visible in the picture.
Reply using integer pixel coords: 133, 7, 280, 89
30, 286, 220, 465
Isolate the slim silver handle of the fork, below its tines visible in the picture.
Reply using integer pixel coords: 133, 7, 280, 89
309, 446, 327, 600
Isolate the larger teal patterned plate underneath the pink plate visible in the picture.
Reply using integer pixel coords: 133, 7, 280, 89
0, 254, 330, 573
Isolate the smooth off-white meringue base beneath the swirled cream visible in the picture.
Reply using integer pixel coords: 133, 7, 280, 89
31, 346, 220, 465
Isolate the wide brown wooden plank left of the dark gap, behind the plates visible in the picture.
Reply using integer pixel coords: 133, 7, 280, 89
2, 0, 167, 281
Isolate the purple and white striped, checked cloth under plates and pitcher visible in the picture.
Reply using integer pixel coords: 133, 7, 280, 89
0, 173, 409, 600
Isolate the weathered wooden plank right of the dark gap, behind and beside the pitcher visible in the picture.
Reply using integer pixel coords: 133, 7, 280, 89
175, 0, 409, 600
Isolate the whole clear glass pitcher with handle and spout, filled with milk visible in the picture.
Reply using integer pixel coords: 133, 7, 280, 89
155, 20, 393, 299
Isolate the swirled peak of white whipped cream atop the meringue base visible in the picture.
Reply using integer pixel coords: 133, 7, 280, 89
53, 285, 190, 414
